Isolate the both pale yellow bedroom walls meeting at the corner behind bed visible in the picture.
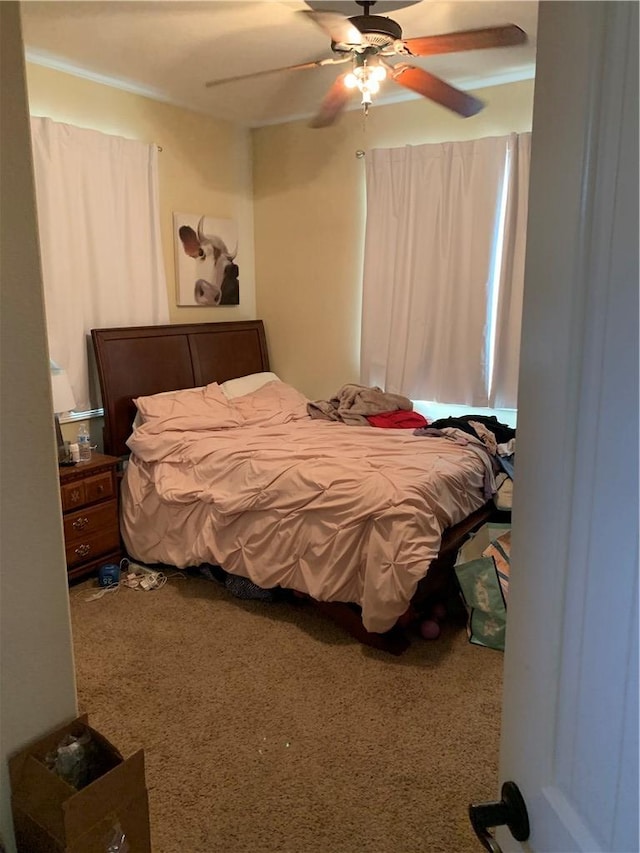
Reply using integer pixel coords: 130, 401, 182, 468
27, 64, 533, 406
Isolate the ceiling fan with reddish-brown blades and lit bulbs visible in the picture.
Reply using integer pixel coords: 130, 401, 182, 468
205, 0, 527, 127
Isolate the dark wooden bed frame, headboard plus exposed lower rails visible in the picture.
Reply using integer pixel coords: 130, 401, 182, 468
91, 320, 496, 654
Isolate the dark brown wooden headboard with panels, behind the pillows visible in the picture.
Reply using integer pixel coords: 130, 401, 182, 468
91, 320, 269, 456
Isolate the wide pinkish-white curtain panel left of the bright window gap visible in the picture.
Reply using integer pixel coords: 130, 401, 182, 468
361, 134, 519, 407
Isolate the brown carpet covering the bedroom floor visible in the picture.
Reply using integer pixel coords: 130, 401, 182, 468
70, 577, 502, 853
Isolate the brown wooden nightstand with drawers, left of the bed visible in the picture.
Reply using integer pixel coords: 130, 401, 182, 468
58, 453, 122, 580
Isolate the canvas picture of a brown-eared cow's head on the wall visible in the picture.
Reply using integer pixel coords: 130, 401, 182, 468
173, 213, 240, 307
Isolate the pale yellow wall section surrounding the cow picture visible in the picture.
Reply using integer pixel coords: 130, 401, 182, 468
27, 63, 255, 323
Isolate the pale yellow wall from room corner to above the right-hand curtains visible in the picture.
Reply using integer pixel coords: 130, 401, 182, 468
253, 80, 534, 399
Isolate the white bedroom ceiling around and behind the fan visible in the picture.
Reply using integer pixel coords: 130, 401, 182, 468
21, 0, 538, 127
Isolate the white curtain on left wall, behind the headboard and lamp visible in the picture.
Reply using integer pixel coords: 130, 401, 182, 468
31, 117, 169, 411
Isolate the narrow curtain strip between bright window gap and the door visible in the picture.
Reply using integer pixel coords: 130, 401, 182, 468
489, 133, 531, 409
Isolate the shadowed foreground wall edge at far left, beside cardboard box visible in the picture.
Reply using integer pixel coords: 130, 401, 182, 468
0, 8, 76, 853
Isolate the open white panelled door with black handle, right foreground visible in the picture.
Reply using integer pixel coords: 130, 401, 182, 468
490, 2, 639, 853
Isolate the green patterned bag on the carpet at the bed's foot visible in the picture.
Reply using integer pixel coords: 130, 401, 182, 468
454, 523, 511, 651
